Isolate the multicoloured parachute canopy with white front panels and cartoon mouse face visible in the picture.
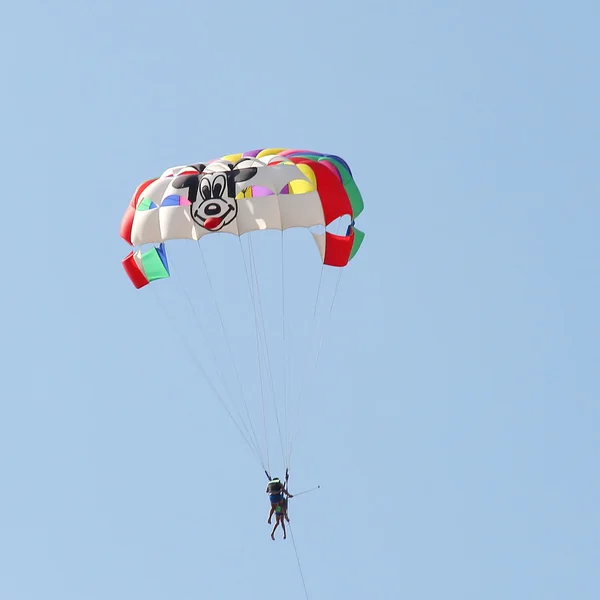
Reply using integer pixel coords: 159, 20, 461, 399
121, 148, 364, 288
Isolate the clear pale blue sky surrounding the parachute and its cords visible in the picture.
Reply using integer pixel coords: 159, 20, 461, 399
0, 0, 600, 600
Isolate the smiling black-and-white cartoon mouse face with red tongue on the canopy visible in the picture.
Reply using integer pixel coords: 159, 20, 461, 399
173, 165, 257, 231
